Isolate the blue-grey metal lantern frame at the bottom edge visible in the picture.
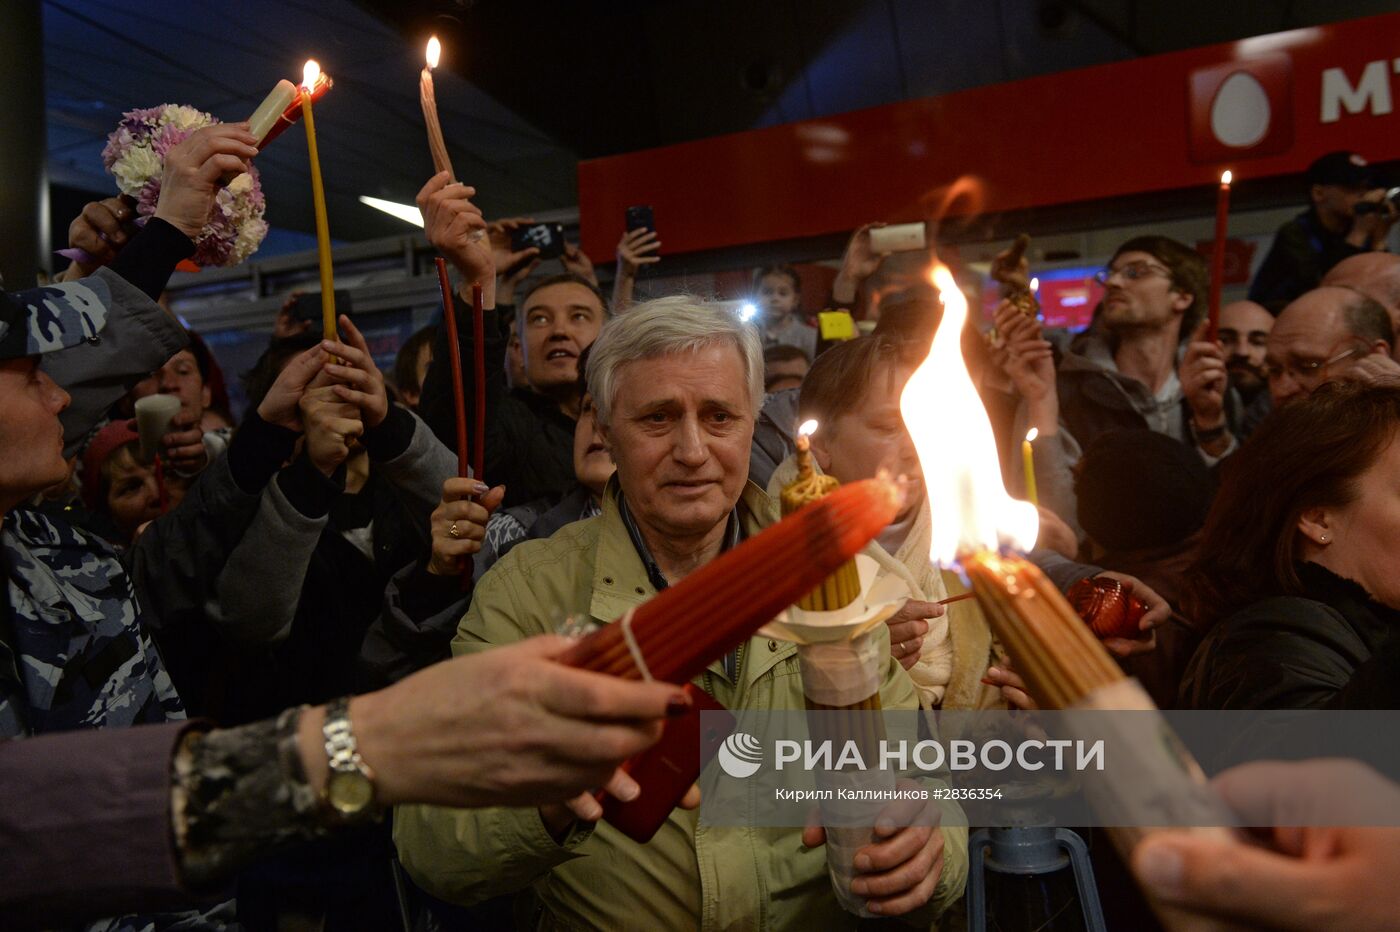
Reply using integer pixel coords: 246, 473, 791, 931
967, 828, 1107, 932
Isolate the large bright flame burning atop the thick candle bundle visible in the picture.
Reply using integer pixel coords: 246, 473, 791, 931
899, 263, 1040, 565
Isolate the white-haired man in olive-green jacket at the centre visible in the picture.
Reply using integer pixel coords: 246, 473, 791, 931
395, 298, 967, 929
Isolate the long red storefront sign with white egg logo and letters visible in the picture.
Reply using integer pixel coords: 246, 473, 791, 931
578, 14, 1400, 261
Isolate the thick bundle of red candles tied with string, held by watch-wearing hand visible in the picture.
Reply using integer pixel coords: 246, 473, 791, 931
561, 479, 900, 683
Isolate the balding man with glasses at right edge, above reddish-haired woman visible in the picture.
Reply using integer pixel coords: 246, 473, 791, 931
1264, 287, 1400, 407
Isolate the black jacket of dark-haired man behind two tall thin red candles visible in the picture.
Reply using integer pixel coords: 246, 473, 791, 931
419, 295, 575, 508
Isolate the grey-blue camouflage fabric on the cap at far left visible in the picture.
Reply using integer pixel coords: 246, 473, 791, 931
0, 277, 112, 360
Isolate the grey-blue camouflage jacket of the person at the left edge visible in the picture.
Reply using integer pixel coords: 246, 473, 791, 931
0, 508, 185, 737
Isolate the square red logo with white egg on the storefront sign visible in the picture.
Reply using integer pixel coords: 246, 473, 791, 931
1187, 53, 1294, 165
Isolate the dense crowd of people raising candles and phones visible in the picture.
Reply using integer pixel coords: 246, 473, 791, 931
0, 118, 1400, 929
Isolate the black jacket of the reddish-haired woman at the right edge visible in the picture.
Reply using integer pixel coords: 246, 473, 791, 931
1180, 563, 1400, 709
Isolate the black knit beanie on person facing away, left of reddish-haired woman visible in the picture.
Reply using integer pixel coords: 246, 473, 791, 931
1074, 428, 1215, 553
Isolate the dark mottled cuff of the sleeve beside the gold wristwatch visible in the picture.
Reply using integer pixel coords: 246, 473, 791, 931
171, 707, 350, 889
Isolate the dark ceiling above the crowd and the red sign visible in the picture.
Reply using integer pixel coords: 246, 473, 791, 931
43, 0, 1400, 250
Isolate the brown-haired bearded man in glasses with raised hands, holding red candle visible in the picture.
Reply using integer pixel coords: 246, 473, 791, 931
997, 236, 1240, 523
